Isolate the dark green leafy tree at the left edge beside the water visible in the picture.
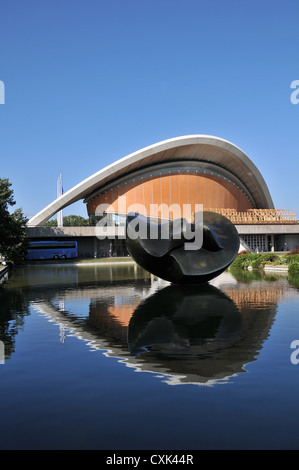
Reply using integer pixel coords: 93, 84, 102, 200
0, 178, 27, 263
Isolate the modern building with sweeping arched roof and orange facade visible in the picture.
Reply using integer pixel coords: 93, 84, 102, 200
28, 135, 299, 256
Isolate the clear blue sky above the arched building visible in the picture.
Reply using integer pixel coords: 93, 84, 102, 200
0, 0, 299, 217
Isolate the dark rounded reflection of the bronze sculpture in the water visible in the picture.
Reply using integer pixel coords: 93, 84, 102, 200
128, 284, 242, 358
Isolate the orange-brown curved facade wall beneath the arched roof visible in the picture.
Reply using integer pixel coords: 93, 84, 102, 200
87, 170, 252, 218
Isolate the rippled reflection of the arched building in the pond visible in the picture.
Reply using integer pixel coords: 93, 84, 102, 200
25, 268, 298, 385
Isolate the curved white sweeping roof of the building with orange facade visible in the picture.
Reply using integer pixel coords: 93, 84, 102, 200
27, 135, 274, 226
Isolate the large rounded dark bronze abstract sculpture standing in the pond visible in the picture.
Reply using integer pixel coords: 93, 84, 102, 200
126, 211, 240, 284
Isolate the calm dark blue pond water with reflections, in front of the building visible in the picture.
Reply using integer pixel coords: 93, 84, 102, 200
0, 264, 299, 450
